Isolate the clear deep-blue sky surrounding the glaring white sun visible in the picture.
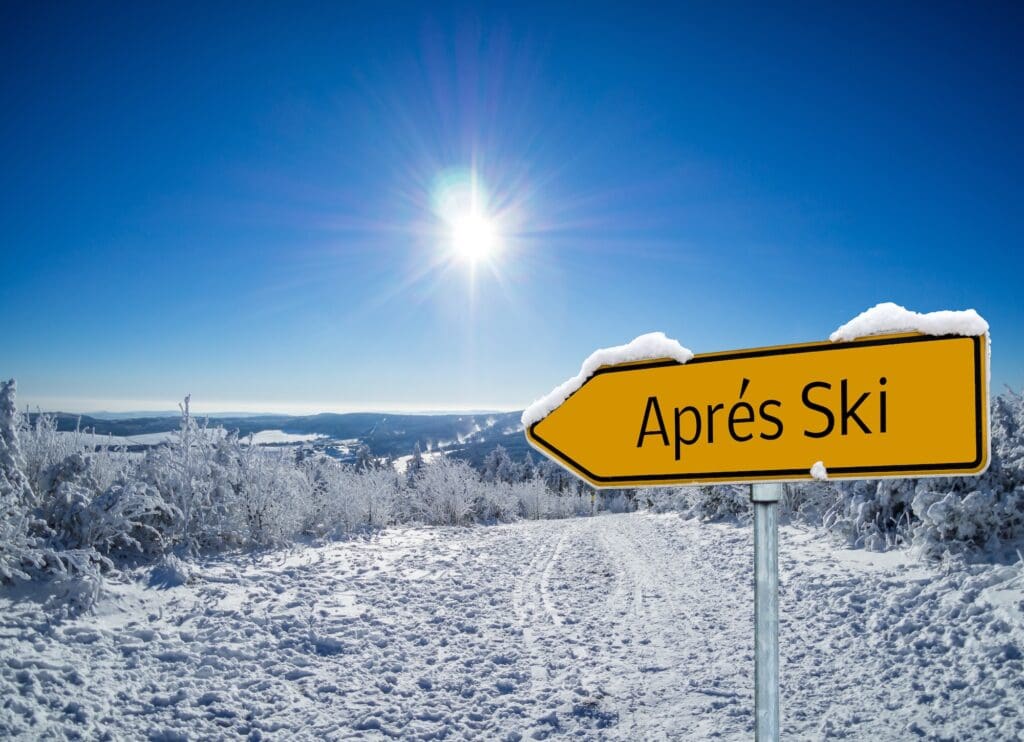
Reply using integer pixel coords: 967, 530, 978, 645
0, 3, 1024, 411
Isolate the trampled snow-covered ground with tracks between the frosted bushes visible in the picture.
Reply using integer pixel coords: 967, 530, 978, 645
0, 515, 1024, 740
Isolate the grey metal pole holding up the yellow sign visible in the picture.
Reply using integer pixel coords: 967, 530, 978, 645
751, 483, 782, 742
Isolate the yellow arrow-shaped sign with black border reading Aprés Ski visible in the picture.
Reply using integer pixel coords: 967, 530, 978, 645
526, 334, 988, 487
